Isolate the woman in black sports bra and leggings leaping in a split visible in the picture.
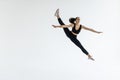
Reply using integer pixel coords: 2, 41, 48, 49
52, 9, 102, 60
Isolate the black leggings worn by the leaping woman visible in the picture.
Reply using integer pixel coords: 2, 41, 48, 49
58, 18, 89, 55
